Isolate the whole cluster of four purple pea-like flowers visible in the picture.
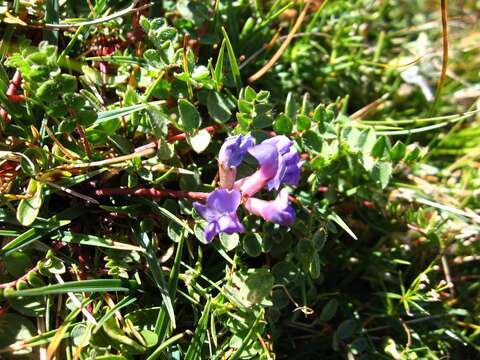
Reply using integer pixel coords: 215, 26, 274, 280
193, 135, 302, 241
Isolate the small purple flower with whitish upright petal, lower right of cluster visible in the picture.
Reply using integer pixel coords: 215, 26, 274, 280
245, 189, 295, 226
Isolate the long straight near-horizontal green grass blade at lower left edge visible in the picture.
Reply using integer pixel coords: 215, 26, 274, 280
5, 279, 137, 298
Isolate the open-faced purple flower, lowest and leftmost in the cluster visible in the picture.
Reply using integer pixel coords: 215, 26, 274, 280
193, 189, 245, 241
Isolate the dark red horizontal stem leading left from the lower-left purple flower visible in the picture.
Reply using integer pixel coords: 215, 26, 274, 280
95, 187, 209, 200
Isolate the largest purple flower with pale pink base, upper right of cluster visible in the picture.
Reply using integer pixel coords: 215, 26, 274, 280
237, 135, 302, 196
